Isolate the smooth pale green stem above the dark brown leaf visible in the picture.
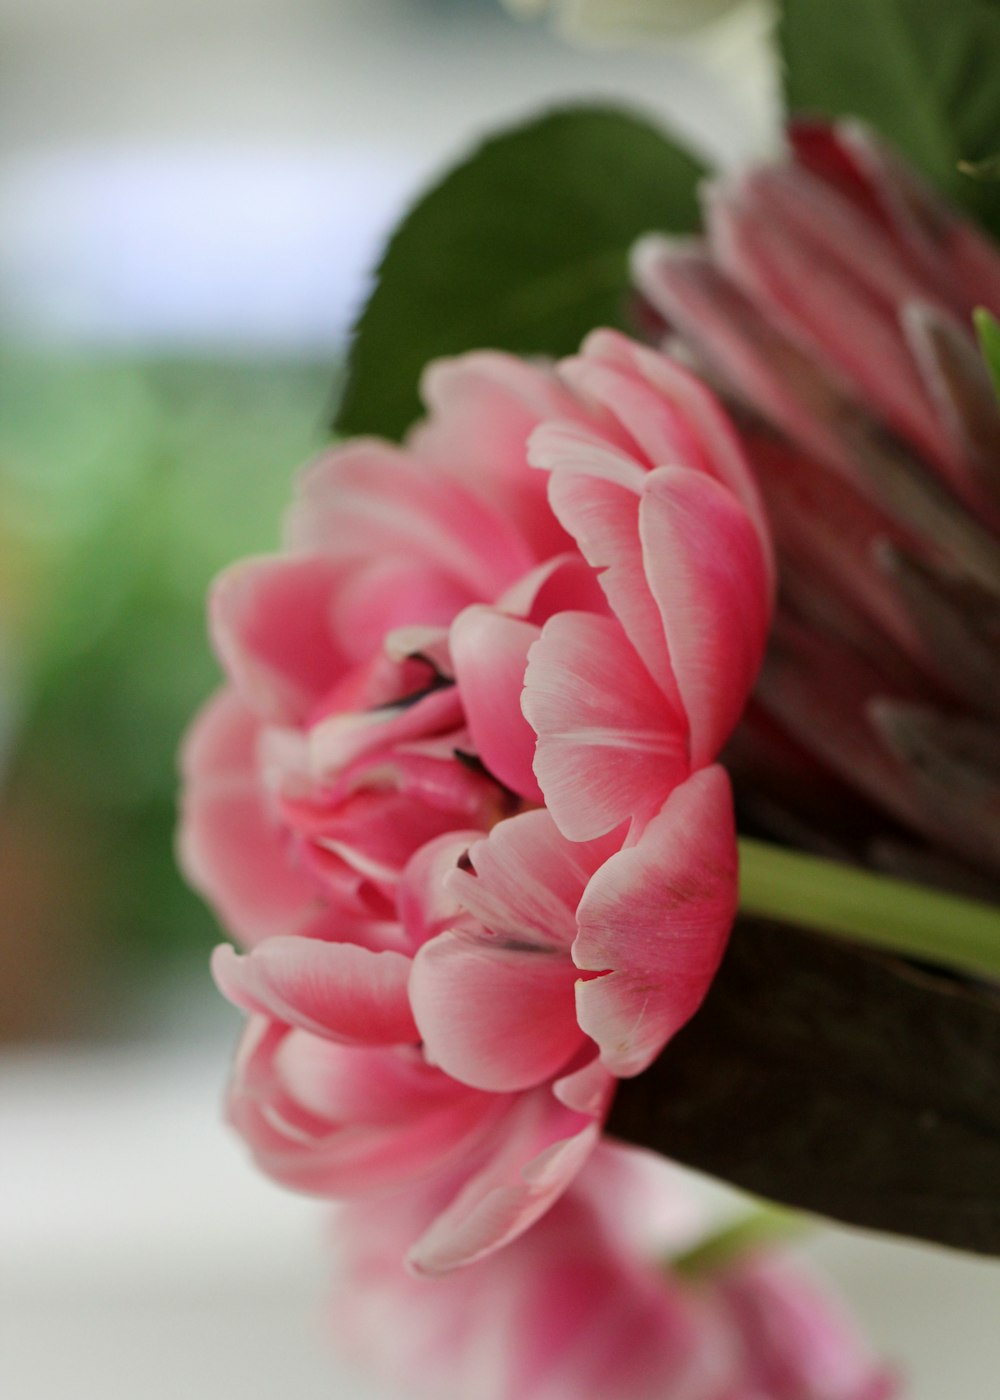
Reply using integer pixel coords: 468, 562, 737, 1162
739, 837, 1000, 981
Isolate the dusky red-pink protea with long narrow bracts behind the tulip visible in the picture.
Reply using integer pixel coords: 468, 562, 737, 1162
634, 123, 1000, 892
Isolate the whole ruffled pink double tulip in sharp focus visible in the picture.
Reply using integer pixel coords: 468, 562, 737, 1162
181, 332, 772, 1273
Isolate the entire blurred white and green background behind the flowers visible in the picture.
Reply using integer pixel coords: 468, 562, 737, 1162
0, 0, 1000, 1400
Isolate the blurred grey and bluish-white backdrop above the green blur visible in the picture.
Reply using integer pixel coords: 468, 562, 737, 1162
0, 0, 762, 353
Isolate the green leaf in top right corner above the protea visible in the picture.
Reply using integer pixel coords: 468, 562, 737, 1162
779, 0, 1000, 228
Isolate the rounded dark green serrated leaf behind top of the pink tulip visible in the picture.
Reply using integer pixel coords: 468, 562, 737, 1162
335, 108, 703, 437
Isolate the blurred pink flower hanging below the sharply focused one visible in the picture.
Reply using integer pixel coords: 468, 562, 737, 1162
332, 1145, 894, 1400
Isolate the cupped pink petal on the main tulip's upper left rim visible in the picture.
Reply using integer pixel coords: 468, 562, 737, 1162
209, 554, 345, 724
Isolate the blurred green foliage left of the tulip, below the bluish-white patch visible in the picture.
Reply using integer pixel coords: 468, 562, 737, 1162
0, 349, 331, 1008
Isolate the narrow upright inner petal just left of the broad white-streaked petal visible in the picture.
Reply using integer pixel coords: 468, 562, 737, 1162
451, 606, 542, 802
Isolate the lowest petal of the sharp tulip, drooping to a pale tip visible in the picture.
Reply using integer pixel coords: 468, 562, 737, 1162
406, 1088, 606, 1275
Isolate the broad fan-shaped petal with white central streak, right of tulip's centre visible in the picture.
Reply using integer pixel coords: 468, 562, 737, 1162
521, 613, 689, 841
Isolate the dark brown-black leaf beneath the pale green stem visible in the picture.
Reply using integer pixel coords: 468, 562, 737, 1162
609, 918, 1000, 1254
